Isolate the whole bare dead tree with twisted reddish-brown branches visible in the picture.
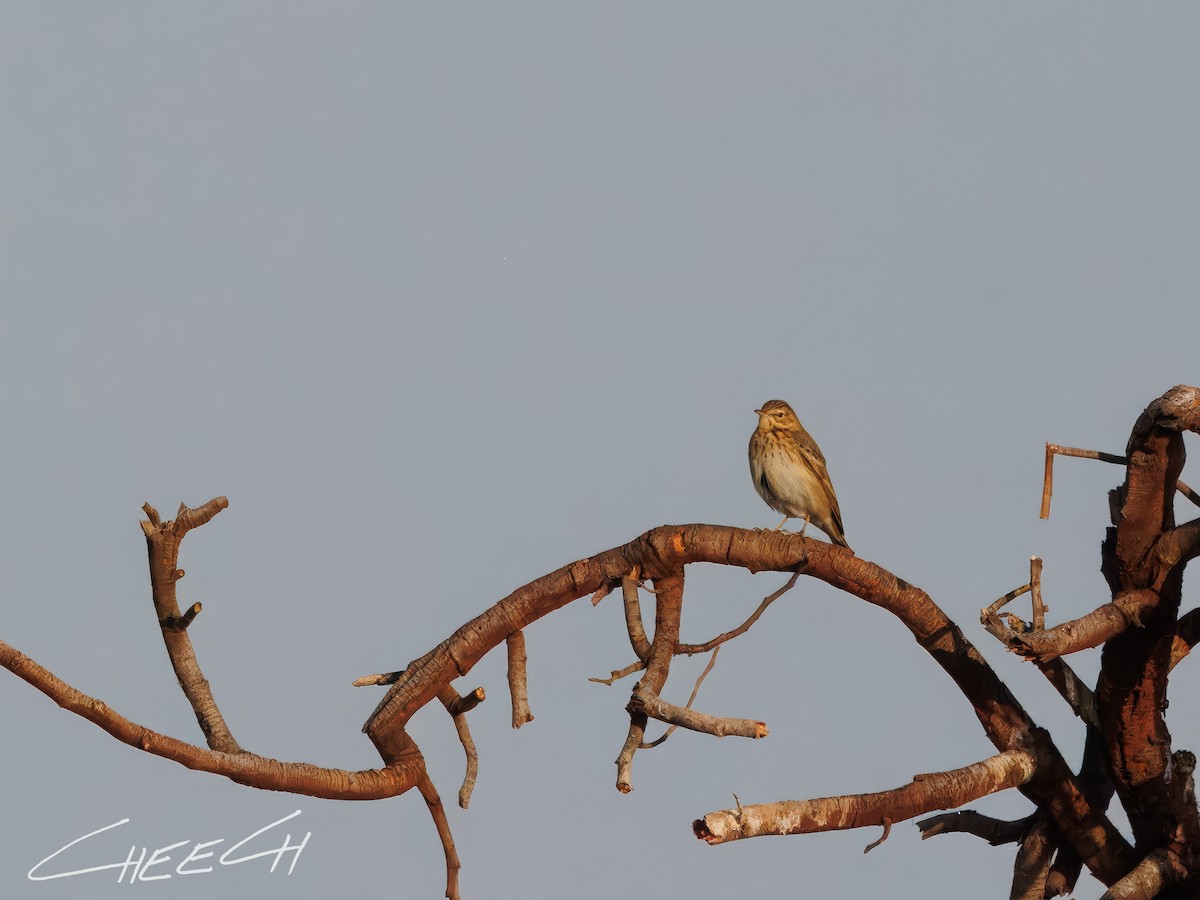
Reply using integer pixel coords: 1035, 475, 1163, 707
0, 386, 1200, 900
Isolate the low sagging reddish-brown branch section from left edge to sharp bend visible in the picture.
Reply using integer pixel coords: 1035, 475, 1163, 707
0, 641, 425, 800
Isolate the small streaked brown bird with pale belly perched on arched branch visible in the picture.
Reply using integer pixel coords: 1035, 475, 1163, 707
750, 400, 850, 550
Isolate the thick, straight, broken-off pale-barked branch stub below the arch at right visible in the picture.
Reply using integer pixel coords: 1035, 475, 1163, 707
691, 750, 1037, 844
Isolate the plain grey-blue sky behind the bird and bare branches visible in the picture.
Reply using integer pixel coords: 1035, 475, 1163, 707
0, 2, 1200, 900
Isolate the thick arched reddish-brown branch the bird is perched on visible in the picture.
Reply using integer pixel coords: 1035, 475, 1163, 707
364, 524, 1134, 883
